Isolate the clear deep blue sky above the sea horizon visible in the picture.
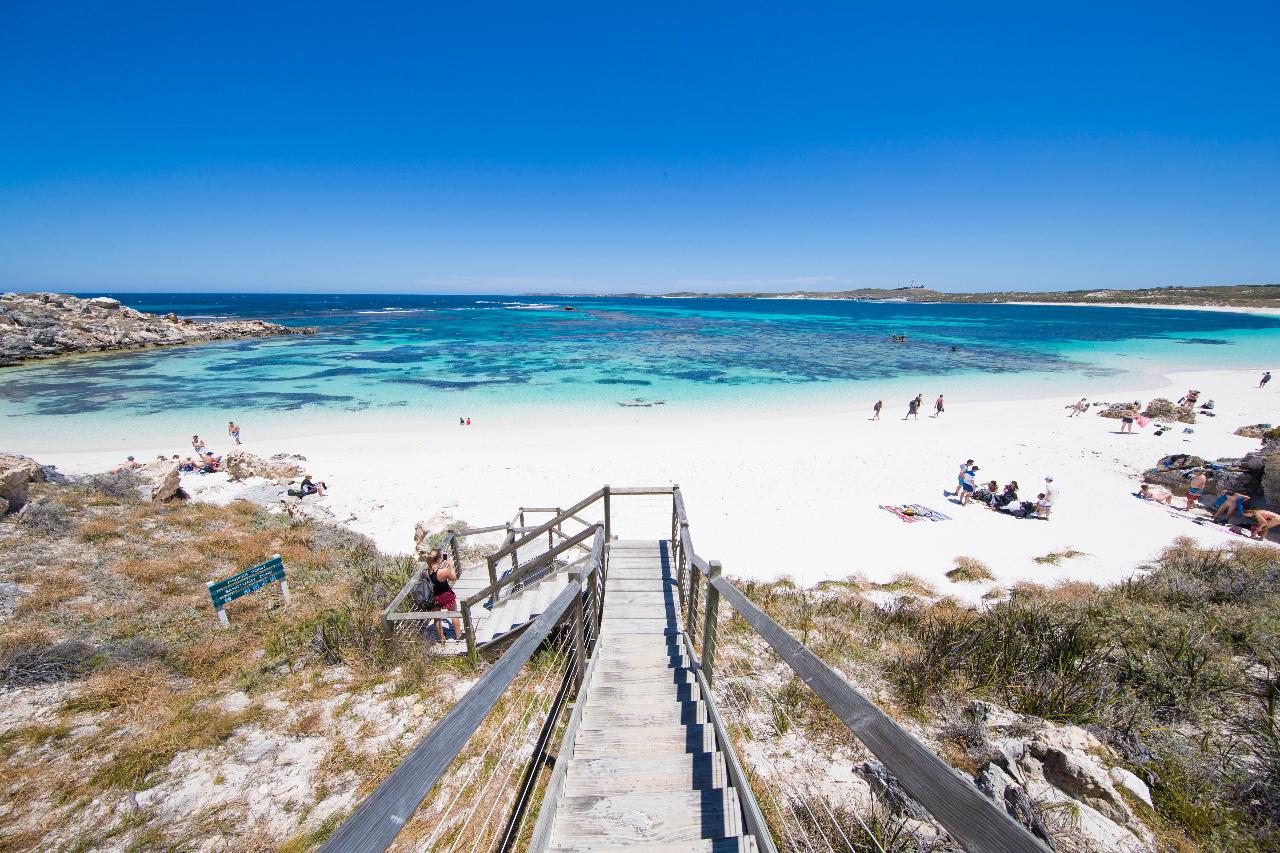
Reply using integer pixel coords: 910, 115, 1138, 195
0, 0, 1280, 292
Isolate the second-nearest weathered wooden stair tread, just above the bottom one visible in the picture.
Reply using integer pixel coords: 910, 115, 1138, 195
563, 752, 728, 797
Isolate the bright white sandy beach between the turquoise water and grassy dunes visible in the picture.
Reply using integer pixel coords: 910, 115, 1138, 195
22, 369, 1280, 599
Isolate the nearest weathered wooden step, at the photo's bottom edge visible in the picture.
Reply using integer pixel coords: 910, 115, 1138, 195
552, 788, 742, 847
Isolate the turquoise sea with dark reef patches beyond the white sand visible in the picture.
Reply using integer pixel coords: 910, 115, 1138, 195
0, 295, 1280, 446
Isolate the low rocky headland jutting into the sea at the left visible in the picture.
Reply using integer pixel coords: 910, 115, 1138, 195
0, 293, 315, 366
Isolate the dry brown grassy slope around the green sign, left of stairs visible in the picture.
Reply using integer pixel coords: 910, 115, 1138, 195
0, 473, 474, 849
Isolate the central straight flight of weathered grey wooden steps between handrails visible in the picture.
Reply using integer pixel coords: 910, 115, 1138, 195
547, 540, 756, 853
